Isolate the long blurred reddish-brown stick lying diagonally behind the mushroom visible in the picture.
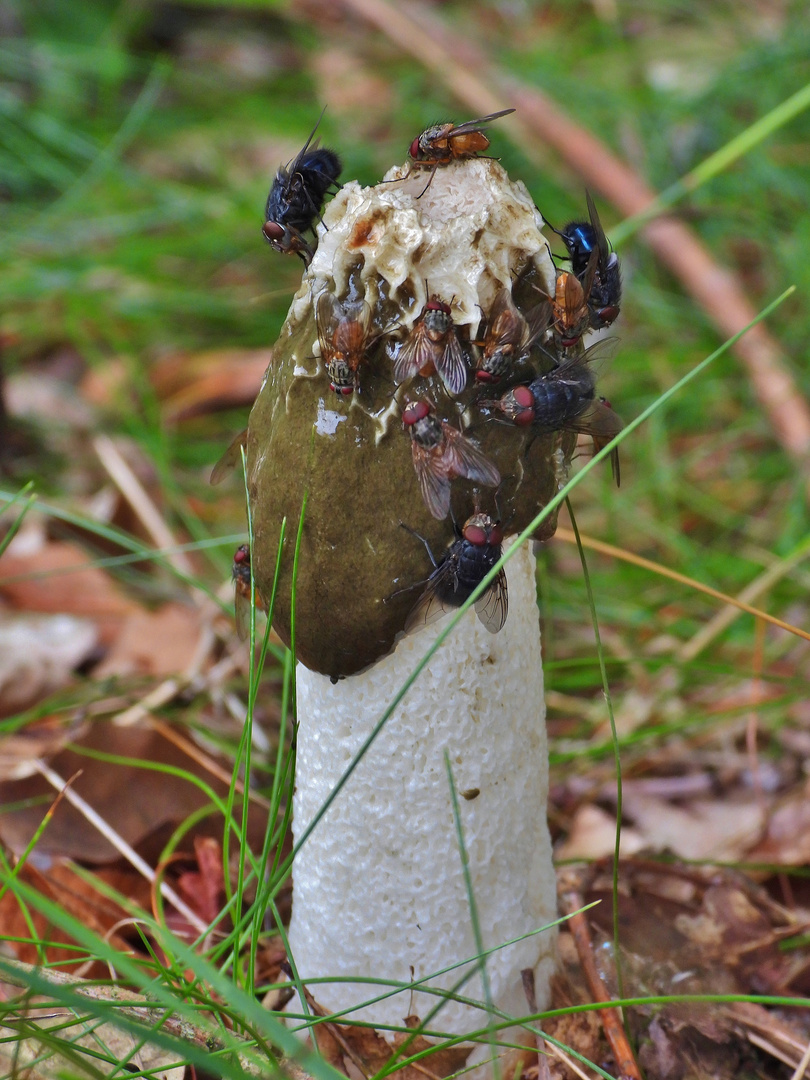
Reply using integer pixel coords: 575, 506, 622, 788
326, 0, 810, 480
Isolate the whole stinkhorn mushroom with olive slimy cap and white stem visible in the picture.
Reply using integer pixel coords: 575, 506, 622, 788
240, 118, 618, 1049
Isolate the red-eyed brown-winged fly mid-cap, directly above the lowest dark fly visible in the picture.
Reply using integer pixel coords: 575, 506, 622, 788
402, 399, 501, 519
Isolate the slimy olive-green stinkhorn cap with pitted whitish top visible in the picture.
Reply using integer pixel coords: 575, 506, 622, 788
247, 159, 572, 677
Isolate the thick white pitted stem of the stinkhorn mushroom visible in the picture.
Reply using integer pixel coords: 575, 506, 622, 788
289, 545, 556, 1034
